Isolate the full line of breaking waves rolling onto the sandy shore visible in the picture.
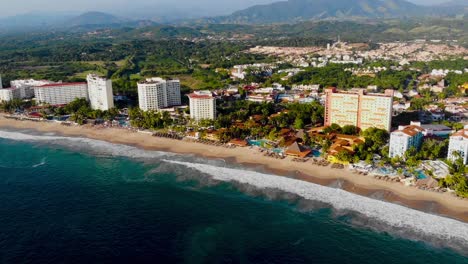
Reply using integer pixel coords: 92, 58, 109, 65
0, 130, 468, 253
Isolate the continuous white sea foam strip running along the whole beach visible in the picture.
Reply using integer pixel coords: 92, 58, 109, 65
0, 130, 468, 250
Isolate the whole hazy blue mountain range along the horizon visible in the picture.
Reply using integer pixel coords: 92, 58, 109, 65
0, 0, 468, 32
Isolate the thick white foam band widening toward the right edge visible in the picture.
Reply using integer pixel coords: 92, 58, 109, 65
164, 160, 468, 249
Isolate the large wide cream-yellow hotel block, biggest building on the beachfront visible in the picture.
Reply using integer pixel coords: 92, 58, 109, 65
325, 88, 394, 131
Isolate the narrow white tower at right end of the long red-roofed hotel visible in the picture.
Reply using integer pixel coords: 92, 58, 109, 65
86, 74, 114, 111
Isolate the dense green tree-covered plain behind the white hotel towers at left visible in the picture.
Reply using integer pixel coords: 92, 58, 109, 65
0, 38, 271, 95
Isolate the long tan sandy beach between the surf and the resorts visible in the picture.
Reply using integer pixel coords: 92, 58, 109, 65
0, 115, 468, 223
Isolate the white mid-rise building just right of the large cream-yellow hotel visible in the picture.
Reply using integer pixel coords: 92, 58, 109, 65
389, 122, 424, 158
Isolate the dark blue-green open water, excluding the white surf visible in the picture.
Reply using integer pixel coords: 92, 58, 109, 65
0, 139, 468, 264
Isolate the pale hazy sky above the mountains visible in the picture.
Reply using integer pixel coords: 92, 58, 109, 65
0, 0, 452, 17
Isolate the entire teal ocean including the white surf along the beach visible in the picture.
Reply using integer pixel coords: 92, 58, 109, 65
0, 130, 468, 264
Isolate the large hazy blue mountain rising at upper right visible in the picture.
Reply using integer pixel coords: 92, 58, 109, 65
219, 0, 463, 23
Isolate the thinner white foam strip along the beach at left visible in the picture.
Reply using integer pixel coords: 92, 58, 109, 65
0, 130, 175, 159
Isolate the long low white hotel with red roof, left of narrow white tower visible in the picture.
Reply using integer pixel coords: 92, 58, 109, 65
34, 82, 88, 105
